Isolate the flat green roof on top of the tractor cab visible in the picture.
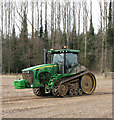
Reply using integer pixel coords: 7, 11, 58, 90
48, 49, 80, 54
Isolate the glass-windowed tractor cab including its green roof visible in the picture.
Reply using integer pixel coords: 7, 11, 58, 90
49, 49, 80, 74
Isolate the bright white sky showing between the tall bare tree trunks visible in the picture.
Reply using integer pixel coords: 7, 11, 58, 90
0, 0, 109, 34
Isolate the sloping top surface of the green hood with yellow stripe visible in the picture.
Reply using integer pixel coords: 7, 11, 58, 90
22, 64, 56, 72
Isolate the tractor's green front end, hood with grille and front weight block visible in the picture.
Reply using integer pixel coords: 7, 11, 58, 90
14, 64, 57, 89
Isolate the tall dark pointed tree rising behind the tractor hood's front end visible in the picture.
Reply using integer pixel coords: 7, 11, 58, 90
19, 7, 29, 69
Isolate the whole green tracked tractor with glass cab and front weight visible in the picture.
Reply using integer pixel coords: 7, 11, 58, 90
14, 48, 96, 97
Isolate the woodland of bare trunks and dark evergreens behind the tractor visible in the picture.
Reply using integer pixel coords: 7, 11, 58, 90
0, 0, 114, 74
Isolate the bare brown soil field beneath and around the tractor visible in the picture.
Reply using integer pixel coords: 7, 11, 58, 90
2, 75, 112, 118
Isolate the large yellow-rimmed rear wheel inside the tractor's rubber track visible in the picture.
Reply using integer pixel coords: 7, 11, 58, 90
81, 73, 96, 94
